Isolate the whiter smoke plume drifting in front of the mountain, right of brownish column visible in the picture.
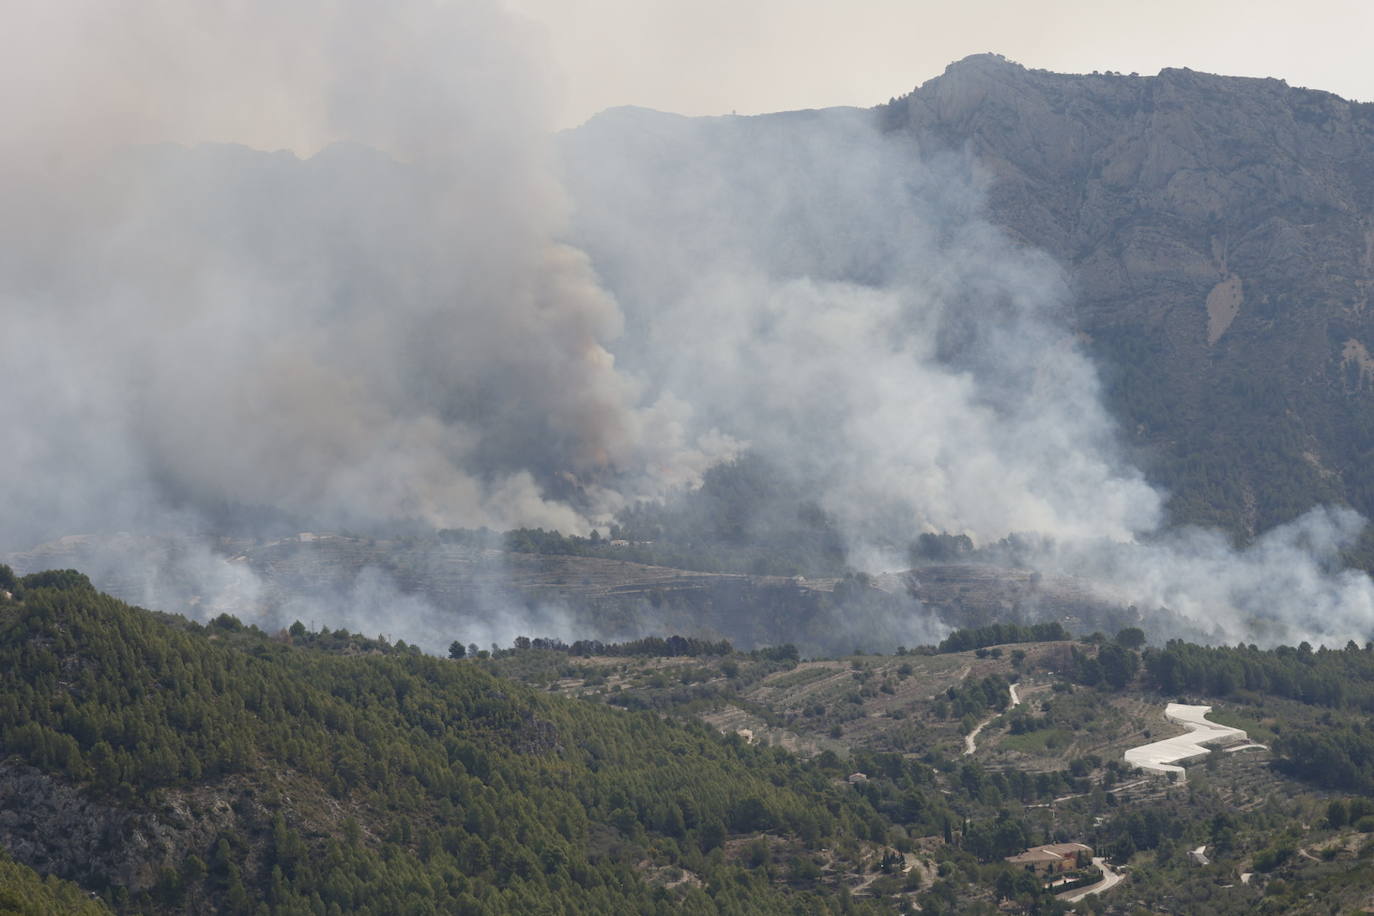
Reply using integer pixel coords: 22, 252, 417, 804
563, 108, 1374, 645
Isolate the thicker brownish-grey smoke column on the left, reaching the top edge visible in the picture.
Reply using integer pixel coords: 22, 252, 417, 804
0, 0, 731, 545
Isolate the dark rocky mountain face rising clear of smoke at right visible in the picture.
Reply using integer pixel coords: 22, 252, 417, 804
879, 55, 1374, 533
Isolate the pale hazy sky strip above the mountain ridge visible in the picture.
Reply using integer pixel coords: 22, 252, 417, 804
510, 0, 1374, 126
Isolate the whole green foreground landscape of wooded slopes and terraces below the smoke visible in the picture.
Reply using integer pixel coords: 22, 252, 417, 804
13, 567, 1374, 916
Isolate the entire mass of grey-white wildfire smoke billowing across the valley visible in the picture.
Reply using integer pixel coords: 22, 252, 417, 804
8, 0, 1374, 639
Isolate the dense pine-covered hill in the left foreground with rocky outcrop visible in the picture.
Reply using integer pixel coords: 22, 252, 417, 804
0, 571, 928, 913
